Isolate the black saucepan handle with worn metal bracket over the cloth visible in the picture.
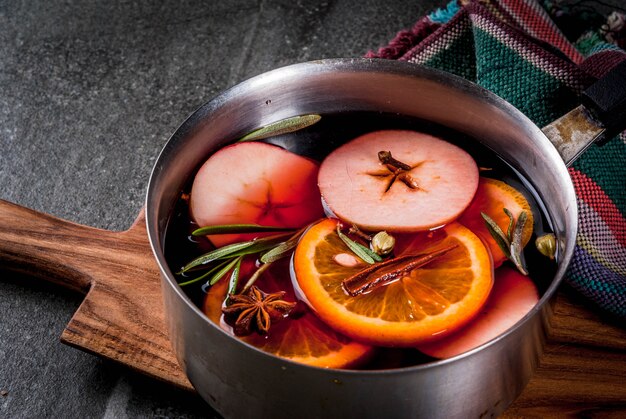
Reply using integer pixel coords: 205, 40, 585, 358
542, 60, 626, 166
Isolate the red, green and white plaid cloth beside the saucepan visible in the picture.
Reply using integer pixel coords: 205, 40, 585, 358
368, 0, 626, 318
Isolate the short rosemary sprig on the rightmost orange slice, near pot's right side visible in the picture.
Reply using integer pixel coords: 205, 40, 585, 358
480, 208, 528, 275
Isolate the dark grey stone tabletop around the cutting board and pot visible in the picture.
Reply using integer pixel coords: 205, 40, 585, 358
0, 0, 438, 418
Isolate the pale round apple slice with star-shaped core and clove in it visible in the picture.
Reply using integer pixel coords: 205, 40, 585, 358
318, 130, 478, 232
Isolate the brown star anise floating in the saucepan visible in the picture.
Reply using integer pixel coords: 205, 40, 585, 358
222, 285, 296, 336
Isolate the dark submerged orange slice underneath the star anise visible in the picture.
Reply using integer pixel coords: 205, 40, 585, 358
203, 260, 374, 368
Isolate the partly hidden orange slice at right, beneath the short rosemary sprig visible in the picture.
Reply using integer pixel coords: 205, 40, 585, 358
459, 177, 533, 268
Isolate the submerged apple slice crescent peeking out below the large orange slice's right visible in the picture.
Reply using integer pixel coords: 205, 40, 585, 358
417, 267, 539, 358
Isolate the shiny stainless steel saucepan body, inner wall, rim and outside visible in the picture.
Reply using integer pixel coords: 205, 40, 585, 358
146, 59, 577, 417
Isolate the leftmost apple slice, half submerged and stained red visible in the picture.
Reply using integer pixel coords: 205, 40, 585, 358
189, 142, 323, 246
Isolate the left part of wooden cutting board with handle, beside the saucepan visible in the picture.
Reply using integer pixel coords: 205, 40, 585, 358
0, 200, 192, 389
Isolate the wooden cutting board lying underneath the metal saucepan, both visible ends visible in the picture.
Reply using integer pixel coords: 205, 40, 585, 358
0, 200, 626, 417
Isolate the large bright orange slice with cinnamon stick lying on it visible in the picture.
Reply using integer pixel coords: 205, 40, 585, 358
293, 219, 493, 346
